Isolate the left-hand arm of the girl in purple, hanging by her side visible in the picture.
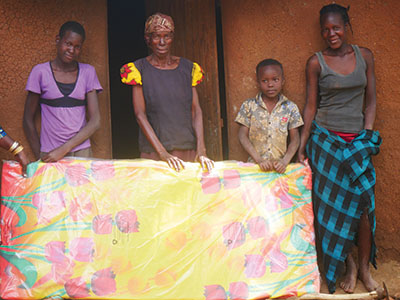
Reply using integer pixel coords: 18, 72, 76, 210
23, 92, 40, 160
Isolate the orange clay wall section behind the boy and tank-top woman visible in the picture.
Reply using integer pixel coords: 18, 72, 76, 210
221, 0, 400, 260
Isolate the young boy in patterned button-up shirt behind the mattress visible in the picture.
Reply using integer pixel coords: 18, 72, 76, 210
235, 59, 303, 173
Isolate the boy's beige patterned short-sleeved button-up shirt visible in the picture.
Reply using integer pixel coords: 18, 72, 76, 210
235, 93, 303, 161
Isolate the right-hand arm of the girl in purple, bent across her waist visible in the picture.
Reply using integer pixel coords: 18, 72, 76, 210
42, 90, 100, 162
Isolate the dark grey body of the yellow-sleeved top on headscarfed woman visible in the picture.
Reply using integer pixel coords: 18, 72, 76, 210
135, 57, 196, 153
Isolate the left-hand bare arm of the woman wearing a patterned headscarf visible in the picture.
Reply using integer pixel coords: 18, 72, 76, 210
132, 85, 184, 171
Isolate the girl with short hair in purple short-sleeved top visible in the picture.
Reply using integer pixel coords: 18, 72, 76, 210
24, 21, 102, 162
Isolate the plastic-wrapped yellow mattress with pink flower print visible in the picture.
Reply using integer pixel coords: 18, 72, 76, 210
0, 158, 320, 300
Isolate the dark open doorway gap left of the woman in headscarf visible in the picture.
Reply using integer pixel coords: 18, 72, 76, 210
107, 0, 147, 159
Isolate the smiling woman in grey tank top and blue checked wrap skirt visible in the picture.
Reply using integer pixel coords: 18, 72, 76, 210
298, 4, 381, 293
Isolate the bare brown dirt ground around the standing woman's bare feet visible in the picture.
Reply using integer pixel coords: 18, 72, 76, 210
321, 259, 400, 297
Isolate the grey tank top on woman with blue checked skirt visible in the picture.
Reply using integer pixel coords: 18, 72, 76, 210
315, 45, 367, 133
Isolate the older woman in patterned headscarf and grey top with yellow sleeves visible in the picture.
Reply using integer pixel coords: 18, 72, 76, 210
121, 13, 214, 171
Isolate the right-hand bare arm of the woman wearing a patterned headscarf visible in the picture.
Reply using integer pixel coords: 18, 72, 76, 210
192, 87, 214, 170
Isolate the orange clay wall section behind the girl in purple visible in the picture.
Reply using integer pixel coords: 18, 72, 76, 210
0, 0, 111, 159
